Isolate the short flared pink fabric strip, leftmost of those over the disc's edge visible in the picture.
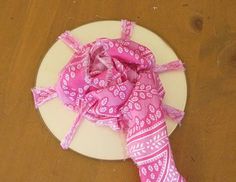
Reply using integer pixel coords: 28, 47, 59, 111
31, 87, 57, 108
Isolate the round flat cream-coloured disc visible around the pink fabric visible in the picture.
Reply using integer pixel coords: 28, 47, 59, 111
36, 21, 187, 160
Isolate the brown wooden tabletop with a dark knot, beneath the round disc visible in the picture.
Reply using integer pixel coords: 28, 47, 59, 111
0, 0, 236, 182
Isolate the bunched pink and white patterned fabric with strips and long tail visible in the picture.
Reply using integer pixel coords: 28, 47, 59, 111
32, 20, 185, 182
